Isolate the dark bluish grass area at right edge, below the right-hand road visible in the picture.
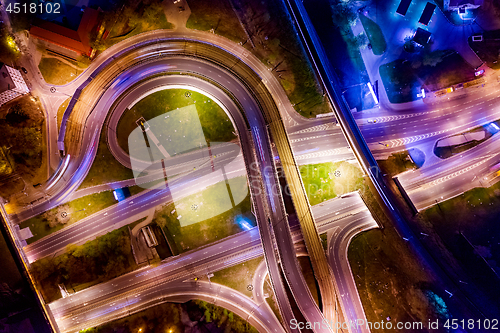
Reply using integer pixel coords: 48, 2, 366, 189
418, 182, 500, 304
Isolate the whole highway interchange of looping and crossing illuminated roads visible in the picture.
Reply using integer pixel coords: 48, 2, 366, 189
2, 4, 500, 332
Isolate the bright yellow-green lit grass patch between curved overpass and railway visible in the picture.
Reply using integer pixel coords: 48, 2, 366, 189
299, 162, 363, 206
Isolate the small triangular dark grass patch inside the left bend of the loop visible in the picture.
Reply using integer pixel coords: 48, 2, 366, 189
78, 123, 134, 189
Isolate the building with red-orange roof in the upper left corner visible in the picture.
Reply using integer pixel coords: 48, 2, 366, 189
30, 7, 100, 59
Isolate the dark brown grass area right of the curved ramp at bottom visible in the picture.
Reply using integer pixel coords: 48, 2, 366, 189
348, 228, 443, 323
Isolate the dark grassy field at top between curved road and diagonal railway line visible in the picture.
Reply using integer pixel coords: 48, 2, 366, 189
187, 0, 331, 117
